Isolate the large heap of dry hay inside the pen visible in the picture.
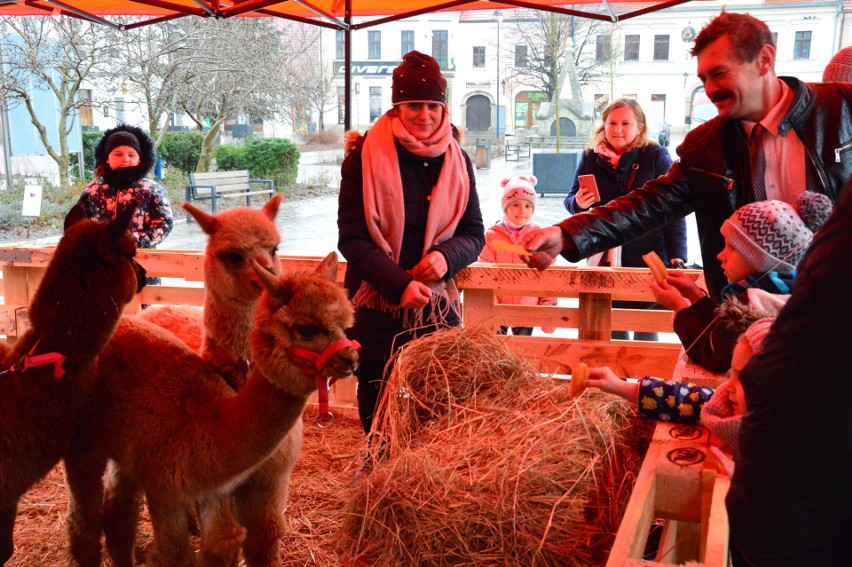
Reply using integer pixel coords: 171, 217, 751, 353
341, 327, 649, 566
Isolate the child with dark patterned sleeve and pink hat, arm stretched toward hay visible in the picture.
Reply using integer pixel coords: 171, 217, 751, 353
585, 318, 775, 457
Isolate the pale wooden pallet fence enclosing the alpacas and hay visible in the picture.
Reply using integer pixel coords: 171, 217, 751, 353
0, 247, 727, 567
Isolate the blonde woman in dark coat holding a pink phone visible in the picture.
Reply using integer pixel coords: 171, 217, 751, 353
565, 98, 686, 341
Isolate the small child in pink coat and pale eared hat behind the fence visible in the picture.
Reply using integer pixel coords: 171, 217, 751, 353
479, 175, 556, 336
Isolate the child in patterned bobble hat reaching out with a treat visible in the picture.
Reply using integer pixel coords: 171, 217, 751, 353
651, 191, 831, 372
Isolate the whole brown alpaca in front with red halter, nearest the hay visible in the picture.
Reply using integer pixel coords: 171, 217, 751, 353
66, 253, 358, 566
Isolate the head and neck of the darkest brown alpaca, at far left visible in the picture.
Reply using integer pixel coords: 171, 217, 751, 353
25, 202, 145, 356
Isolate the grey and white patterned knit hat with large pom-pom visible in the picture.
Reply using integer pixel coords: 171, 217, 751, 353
721, 191, 832, 274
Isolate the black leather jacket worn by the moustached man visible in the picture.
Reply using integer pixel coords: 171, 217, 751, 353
559, 77, 852, 301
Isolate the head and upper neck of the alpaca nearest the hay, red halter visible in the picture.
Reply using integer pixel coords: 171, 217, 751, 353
251, 252, 358, 396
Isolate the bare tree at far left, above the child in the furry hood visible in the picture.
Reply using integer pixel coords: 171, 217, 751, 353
0, 16, 113, 189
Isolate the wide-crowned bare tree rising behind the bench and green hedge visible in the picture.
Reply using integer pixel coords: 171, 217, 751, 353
175, 18, 289, 171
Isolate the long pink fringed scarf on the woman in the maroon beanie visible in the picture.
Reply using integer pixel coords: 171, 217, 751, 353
352, 110, 470, 328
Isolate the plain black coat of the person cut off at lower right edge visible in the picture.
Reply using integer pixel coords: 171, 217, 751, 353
727, 183, 852, 567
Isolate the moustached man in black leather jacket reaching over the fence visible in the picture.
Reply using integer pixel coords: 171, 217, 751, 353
523, 12, 852, 301
